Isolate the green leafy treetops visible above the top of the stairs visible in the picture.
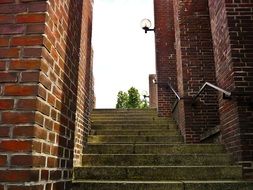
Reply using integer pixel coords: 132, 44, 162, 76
116, 87, 149, 109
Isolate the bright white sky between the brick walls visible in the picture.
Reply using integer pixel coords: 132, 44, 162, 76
92, 0, 155, 108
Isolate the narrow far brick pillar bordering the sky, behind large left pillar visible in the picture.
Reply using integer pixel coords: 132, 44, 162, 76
71, 1, 94, 165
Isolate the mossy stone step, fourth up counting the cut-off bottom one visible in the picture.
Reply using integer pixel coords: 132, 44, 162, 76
85, 143, 225, 154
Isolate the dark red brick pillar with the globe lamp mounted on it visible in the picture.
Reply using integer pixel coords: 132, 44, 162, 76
154, 0, 177, 116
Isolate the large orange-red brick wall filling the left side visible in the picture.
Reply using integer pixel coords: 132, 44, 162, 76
0, 0, 91, 190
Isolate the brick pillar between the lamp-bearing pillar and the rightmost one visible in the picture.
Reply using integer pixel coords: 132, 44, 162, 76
173, 0, 219, 143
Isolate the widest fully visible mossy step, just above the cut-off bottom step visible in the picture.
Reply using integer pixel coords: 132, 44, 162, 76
74, 166, 242, 181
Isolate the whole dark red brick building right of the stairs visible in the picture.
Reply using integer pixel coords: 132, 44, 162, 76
154, 0, 253, 179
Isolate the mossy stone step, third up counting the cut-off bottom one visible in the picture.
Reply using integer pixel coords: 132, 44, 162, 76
83, 154, 233, 166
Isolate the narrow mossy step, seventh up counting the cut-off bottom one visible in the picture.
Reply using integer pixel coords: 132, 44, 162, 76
91, 123, 178, 130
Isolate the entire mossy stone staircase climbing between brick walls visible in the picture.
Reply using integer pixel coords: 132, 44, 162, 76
73, 109, 253, 190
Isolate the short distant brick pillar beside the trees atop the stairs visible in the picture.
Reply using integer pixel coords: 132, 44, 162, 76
149, 74, 157, 108
